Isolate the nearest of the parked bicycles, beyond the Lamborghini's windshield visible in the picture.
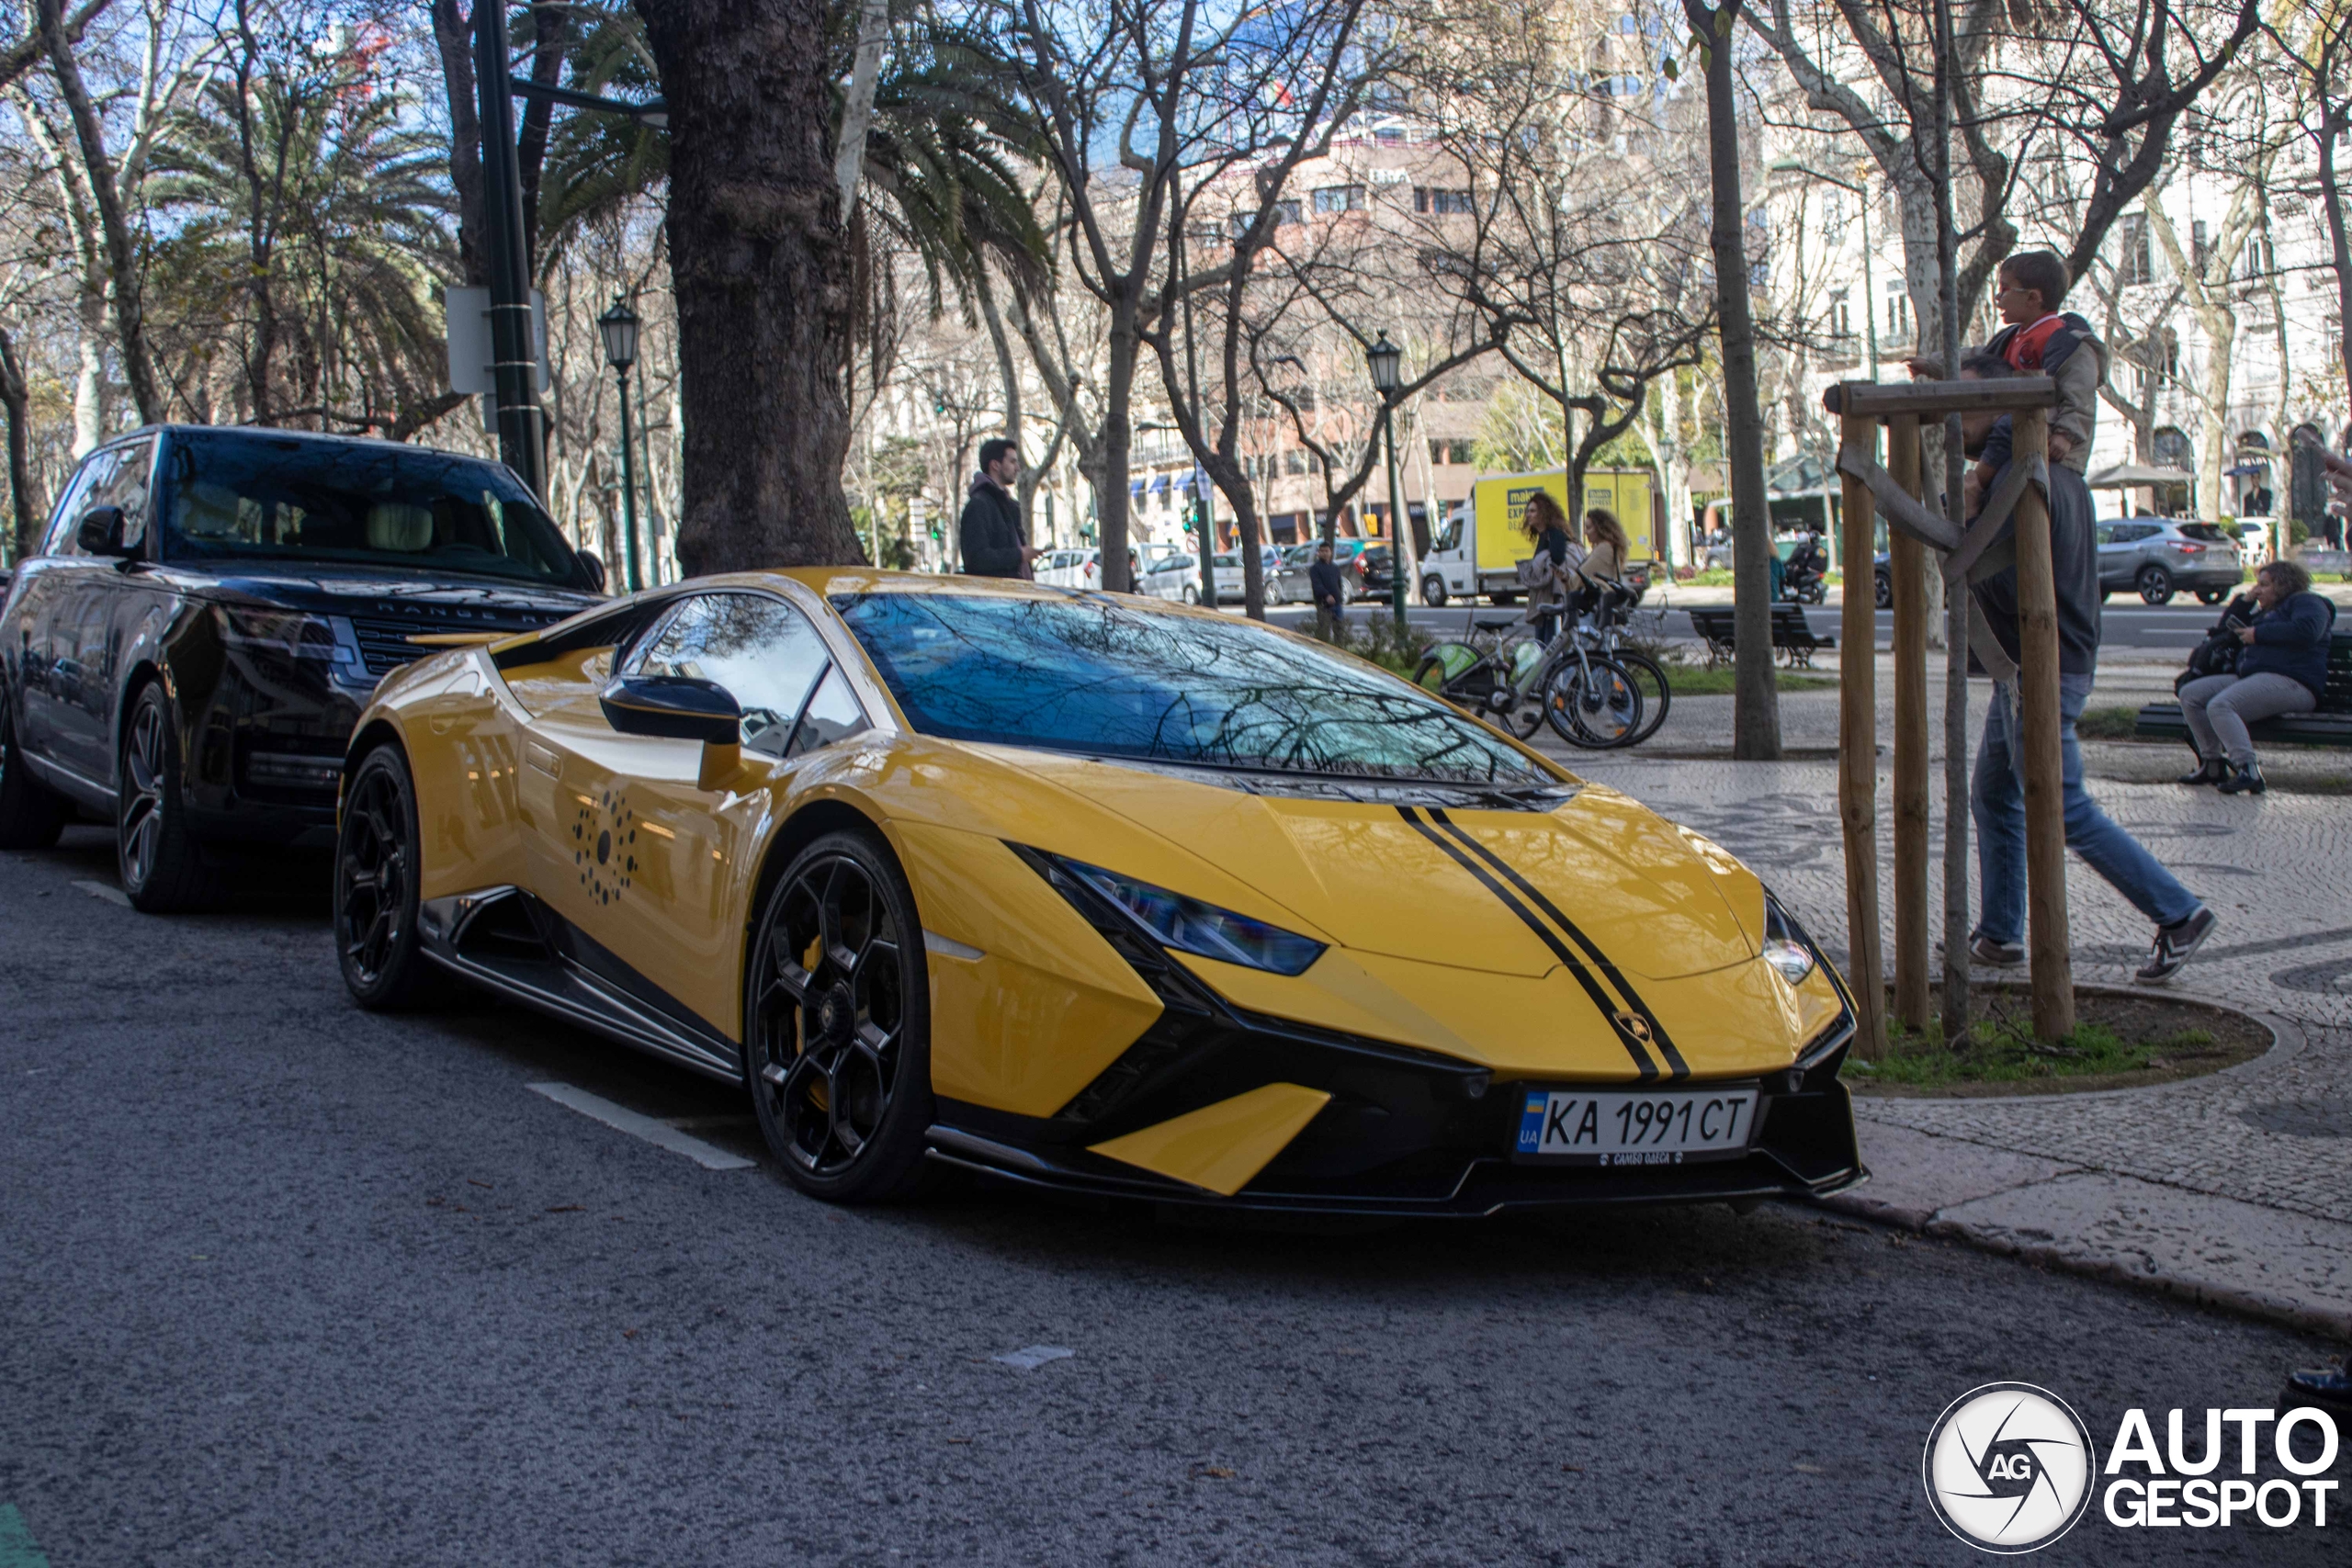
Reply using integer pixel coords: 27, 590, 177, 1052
1414, 618, 1642, 750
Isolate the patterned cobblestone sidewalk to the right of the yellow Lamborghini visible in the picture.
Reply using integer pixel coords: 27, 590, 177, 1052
1557, 747, 2352, 1337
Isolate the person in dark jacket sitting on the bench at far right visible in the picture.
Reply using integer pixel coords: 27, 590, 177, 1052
2180, 562, 2335, 795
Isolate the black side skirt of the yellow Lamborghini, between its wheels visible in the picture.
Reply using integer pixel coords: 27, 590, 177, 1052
416, 886, 743, 1084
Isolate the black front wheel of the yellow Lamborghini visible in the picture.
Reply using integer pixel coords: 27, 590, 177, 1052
743, 832, 932, 1203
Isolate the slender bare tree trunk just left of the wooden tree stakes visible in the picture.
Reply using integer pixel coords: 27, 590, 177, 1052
1681, 0, 1778, 761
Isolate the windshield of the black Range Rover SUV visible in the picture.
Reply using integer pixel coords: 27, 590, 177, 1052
163, 430, 585, 588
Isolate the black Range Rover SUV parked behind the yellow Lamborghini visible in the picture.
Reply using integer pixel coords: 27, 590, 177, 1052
0, 425, 605, 912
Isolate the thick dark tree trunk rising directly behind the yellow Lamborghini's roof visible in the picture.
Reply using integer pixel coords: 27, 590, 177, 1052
638, 0, 864, 576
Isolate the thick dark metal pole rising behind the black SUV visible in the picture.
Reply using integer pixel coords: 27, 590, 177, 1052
473, 0, 548, 503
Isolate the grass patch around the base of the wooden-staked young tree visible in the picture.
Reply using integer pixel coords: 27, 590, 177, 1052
1847, 985, 2269, 1096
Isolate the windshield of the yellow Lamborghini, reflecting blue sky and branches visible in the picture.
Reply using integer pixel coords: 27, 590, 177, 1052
832, 592, 1559, 790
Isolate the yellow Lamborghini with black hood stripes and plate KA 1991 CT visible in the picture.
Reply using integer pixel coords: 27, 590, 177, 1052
334, 569, 1860, 1215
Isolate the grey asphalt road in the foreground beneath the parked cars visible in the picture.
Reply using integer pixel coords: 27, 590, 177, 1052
0, 828, 2352, 1568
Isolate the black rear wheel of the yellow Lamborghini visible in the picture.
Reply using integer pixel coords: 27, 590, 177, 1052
334, 745, 454, 1013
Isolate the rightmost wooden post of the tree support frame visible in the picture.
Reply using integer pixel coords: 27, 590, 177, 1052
2008, 409, 2075, 1043
